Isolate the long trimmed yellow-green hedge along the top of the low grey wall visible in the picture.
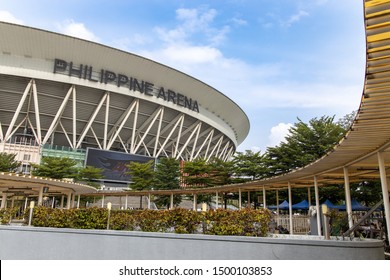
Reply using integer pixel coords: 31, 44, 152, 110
24, 206, 270, 236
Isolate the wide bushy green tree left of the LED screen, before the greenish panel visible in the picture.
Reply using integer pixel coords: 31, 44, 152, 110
31, 157, 78, 179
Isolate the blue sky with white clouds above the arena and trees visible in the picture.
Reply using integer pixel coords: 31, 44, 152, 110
0, 0, 365, 152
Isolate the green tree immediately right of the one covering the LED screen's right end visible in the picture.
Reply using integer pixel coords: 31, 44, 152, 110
154, 157, 181, 208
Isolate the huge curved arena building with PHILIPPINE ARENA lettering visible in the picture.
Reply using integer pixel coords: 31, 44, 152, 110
0, 22, 249, 187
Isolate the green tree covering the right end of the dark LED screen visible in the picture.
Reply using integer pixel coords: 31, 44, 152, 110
126, 160, 155, 208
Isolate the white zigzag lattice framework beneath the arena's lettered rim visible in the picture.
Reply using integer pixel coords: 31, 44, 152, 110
0, 75, 235, 160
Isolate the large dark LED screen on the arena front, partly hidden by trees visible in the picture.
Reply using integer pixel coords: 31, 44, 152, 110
85, 148, 154, 182
